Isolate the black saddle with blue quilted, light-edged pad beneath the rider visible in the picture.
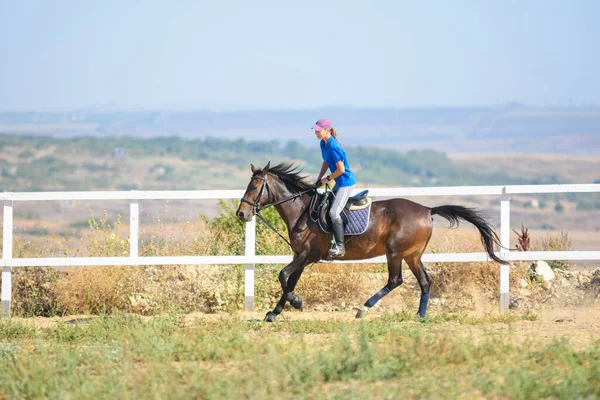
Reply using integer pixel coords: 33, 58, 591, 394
317, 190, 371, 235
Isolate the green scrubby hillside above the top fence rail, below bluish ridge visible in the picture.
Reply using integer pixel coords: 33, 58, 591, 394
0, 134, 600, 195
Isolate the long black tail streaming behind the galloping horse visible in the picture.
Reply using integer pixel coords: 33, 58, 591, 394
430, 205, 508, 264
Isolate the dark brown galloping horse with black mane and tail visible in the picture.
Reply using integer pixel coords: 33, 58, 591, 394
236, 162, 506, 321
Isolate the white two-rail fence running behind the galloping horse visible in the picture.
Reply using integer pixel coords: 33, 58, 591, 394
0, 184, 600, 316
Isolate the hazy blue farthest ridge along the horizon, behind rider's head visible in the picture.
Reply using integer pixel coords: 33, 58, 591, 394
0, 104, 600, 154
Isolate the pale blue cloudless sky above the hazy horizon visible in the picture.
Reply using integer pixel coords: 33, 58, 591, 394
0, 0, 600, 111
